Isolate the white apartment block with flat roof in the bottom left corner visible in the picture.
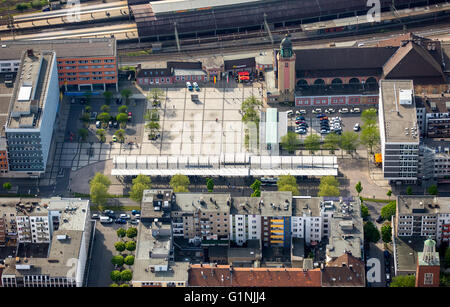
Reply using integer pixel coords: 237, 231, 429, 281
1, 197, 92, 287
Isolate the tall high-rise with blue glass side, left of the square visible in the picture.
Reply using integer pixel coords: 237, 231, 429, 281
5, 49, 59, 177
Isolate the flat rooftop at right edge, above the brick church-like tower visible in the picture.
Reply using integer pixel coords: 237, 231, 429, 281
397, 195, 450, 214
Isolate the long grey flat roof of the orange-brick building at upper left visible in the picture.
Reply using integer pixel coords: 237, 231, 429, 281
0, 38, 116, 60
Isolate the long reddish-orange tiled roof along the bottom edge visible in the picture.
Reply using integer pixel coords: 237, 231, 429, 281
188, 264, 322, 287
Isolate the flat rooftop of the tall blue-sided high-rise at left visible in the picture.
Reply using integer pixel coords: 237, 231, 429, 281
6, 51, 55, 130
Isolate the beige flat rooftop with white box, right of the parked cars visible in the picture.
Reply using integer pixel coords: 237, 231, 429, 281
380, 80, 419, 143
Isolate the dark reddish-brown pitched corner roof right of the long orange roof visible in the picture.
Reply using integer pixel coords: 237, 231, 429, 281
322, 253, 365, 287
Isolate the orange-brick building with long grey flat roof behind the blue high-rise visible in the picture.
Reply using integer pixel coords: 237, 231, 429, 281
0, 38, 118, 91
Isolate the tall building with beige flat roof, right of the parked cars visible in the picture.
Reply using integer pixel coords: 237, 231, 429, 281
378, 80, 419, 184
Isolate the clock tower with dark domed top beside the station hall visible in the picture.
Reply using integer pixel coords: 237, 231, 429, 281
277, 34, 295, 102
